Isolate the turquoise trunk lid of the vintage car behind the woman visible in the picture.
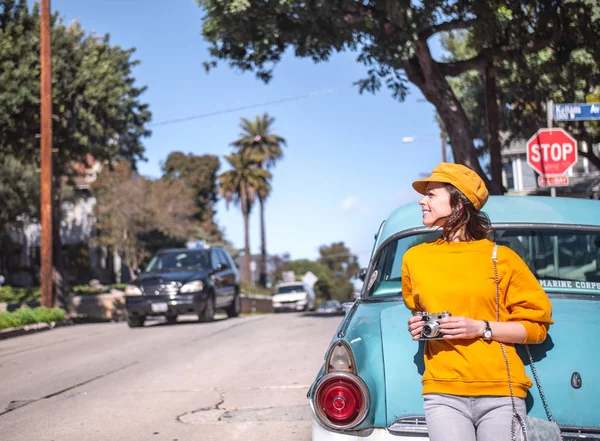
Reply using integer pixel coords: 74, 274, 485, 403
381, 294, 600, 427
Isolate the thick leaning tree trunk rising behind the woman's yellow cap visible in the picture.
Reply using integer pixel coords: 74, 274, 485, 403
403, 41, 502, 194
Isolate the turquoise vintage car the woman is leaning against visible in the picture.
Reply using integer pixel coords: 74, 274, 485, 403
308, 196, 600, 441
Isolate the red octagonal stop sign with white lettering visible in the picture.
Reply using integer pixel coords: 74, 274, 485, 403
527, 129, 577, 176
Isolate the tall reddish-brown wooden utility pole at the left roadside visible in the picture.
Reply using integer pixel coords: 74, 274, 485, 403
40, 0, 54, 308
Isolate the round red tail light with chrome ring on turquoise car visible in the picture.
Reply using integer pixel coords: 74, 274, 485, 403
314, 373, 369, 429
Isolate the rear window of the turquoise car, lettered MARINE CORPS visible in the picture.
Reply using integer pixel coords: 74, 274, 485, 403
366, 228, 600, 296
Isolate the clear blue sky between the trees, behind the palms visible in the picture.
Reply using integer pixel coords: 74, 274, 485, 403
47, 0, 448, 266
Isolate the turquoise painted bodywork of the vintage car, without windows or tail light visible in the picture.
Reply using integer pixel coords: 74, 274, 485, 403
308, 196, 600, 441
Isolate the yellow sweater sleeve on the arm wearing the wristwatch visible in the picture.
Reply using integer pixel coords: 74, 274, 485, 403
506, 250, 554, 343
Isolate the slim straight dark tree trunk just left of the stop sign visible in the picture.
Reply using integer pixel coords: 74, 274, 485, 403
483, 65, 504, 193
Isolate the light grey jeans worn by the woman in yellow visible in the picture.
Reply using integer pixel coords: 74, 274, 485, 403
423, 394, 527, 441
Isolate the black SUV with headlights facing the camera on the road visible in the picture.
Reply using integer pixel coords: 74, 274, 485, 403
125, 246, 241, 328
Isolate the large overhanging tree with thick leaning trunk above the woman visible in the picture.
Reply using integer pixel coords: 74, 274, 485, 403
197, 0, 600, 193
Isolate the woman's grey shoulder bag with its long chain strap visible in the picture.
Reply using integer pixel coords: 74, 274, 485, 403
492, 245, 562, 441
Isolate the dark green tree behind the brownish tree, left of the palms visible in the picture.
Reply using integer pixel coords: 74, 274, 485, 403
162, 152, 223, 243
